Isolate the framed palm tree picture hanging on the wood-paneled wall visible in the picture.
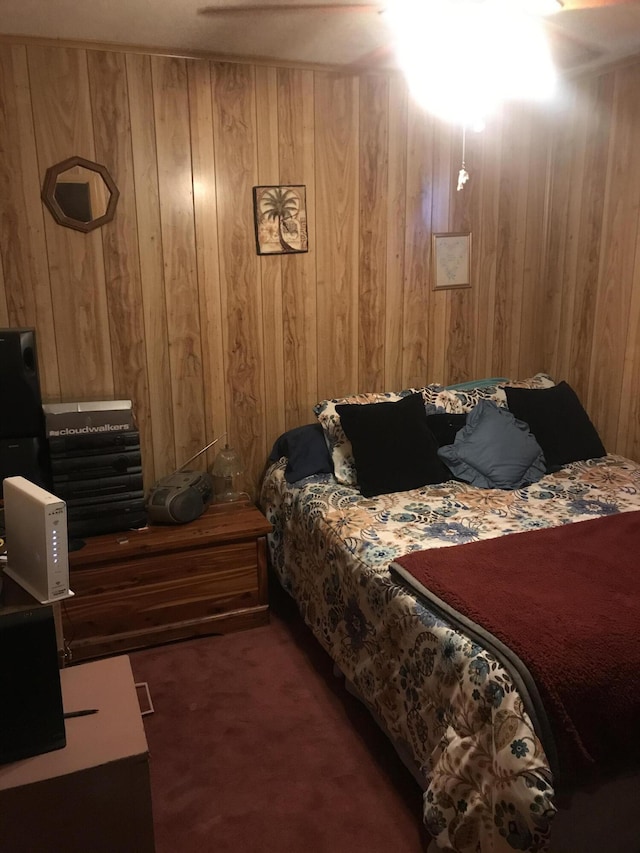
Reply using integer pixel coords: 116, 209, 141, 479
253, 184, 309, 255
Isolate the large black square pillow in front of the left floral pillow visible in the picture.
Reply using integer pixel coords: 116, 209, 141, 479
336, 394, 451, 498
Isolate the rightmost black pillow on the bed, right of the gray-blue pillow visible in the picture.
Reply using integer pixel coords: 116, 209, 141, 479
504, 382, 607, 471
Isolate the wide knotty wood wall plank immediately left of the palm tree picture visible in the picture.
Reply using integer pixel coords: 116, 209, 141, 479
211, 63, 270, 490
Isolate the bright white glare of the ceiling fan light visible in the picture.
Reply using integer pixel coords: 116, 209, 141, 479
387, 0, 556, 126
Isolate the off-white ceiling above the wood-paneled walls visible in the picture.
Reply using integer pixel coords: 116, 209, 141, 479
0, 0, 640, 73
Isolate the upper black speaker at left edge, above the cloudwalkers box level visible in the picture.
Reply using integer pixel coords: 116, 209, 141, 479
0, 329, 44, 438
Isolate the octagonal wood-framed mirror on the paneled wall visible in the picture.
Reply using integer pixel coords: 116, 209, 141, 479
42, 157, 120, 232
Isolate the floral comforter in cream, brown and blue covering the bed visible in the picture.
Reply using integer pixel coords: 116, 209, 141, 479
261, 455, 640, 853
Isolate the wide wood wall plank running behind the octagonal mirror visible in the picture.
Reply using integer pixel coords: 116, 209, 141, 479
27, 47, 114, 401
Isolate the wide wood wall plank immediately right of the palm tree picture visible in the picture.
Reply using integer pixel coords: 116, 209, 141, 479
315, 73, 359, 398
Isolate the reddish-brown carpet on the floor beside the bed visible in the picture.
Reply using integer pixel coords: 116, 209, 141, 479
130, 590, 426, 853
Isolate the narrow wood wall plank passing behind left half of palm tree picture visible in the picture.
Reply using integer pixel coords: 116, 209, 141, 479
256, 66, 290, 439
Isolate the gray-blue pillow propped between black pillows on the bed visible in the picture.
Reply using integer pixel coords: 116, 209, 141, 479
438, 400, 546, 489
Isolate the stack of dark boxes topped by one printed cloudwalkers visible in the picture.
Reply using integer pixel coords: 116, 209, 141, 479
43, 400, 147, 538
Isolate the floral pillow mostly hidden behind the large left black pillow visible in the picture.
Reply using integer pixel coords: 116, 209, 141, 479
313, 385, 442, 486
